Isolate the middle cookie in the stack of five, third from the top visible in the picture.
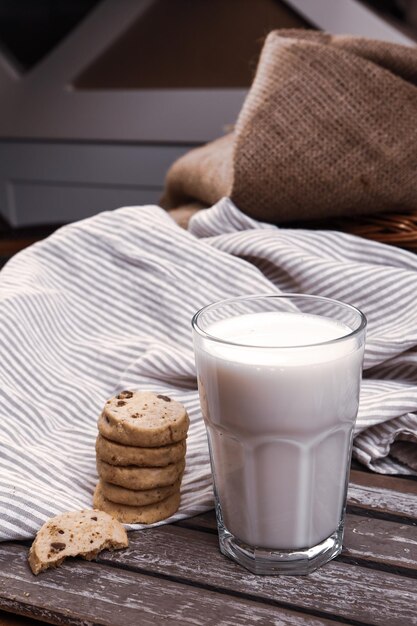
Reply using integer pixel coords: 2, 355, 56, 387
97, 459, 185, 490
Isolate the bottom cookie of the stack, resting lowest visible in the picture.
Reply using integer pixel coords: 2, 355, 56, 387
93, 483, 181, 524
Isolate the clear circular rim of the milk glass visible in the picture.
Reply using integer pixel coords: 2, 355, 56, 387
191, 293, 367, 350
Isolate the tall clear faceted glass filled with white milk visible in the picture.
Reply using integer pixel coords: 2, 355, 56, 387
192, 295, 366, 574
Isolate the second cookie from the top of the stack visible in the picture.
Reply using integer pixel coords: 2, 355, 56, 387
96, 435, 186, 467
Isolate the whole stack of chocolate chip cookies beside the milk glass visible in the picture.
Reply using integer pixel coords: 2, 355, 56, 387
93, 391, 189, 524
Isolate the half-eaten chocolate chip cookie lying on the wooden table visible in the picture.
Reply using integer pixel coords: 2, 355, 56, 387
29, 509, 129, 574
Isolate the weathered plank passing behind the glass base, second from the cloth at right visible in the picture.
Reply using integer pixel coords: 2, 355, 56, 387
176, 511, 417, 572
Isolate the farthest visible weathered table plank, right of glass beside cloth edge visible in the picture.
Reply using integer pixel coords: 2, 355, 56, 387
348, 470, 417, 522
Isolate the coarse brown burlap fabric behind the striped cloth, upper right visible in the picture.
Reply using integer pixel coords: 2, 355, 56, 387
163, 30, 417, 223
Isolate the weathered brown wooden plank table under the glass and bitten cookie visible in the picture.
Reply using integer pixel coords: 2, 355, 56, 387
0, 469, 417, 626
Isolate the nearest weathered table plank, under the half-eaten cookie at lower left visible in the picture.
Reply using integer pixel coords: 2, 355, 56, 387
0, 533, 331, 626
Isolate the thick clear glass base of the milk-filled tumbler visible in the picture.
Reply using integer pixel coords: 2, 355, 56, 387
217, 519, 343, 575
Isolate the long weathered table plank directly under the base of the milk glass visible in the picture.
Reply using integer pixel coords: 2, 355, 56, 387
99, 525, 417, 626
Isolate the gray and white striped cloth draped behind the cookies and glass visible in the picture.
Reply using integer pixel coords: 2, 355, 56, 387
0, 199, 417, 540
